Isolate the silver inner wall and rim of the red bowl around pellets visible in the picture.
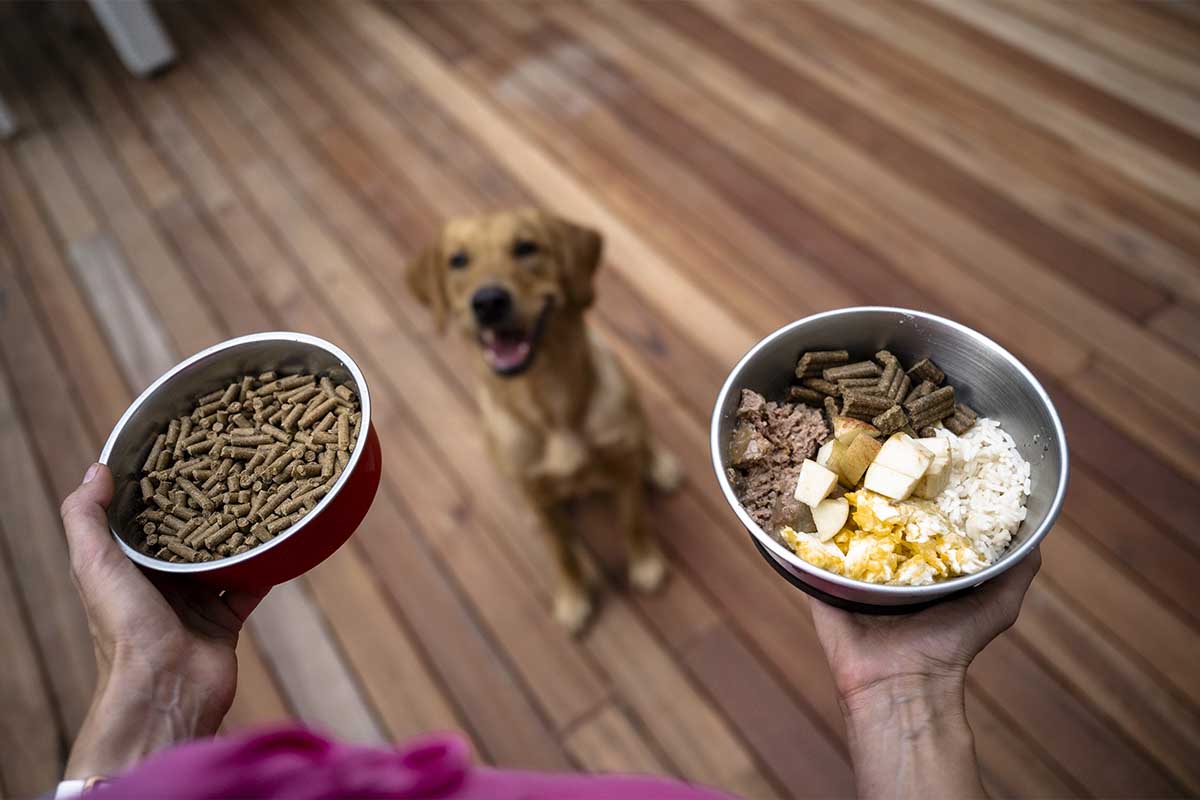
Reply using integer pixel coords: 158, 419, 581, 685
102, 335, 370, 572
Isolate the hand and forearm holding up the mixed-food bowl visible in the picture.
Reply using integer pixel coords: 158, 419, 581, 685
811, 551, 1042, 799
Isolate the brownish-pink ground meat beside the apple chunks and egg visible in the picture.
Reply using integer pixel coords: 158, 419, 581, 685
730, 389, 829, 534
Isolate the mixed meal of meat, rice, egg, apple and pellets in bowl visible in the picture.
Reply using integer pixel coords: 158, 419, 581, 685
727, 350, 1031, 587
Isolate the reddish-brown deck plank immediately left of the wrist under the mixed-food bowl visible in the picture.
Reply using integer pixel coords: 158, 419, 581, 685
685, 625, 854, 798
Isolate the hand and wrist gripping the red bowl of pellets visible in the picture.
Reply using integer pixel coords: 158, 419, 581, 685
61, 464, 265, 777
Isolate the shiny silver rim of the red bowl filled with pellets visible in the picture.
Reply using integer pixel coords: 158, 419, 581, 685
100, 331, 371, 575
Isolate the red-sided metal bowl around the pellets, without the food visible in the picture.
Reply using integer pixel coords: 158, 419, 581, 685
100, 331, 383, 590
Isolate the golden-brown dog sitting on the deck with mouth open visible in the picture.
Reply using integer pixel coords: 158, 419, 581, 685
407, 209, 680, 633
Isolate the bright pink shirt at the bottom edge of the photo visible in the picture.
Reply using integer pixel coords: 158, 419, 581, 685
90, 727, 730, 800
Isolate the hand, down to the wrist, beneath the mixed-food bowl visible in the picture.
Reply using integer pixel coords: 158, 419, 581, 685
810, 549, 1042, 702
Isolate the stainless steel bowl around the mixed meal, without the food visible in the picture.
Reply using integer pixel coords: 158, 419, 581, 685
710, 306, 1068, 608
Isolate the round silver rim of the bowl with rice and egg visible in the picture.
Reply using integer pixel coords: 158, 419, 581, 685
709, 306, 1070, 601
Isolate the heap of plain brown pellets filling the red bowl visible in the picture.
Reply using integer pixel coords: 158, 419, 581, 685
134, 372, 362, 563
